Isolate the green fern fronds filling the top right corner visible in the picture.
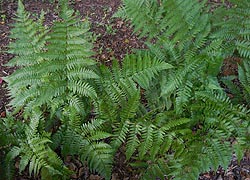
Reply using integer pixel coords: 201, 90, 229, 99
214, 0, 250, 59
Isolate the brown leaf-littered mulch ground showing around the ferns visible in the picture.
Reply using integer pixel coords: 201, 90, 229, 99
0, 0, 250, 180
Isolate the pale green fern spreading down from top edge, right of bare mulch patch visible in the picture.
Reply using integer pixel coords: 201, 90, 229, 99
118, 0, 223, 113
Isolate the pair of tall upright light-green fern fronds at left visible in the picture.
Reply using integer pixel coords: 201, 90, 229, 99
6, 1, 98, 114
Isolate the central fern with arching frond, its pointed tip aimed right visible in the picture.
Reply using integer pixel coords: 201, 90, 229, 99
96, 53, 172, 126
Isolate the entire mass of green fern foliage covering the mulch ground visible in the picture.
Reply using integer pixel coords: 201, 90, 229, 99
0, 0, 250, 179
